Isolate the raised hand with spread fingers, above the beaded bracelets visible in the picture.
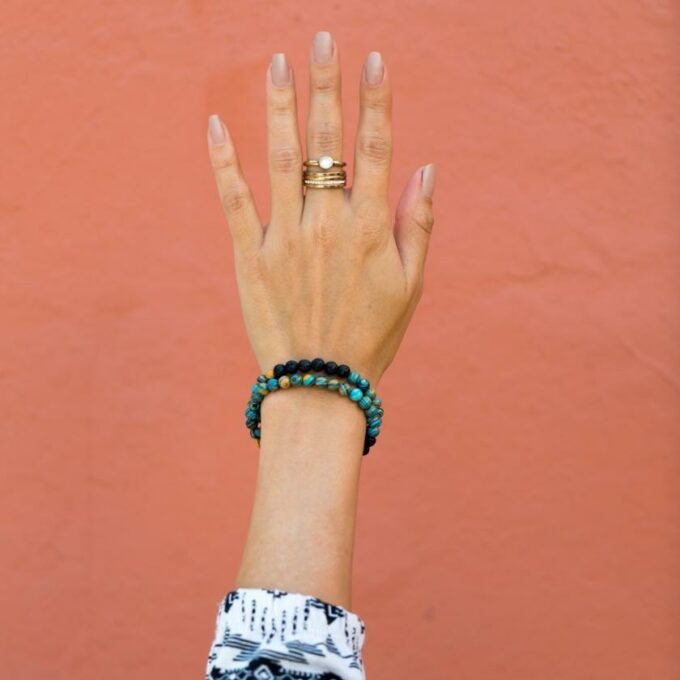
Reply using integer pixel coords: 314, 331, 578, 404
208, 31, 435, 386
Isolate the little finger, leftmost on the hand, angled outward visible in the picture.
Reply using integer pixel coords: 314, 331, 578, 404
208, 114, 263, 255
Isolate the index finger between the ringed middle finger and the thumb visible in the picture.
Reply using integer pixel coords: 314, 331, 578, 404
351, 52, 392, 208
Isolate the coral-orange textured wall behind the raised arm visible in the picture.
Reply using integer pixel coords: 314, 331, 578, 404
0, 0, 680, 680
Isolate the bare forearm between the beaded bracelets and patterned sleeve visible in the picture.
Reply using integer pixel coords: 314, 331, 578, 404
236, 388, 366, 608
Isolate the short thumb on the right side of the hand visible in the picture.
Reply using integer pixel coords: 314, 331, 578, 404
394, 163, 435, 287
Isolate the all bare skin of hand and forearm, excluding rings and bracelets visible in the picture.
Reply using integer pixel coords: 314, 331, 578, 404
208, 31, 435, 608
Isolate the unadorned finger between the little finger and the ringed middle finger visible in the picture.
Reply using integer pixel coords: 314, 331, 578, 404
267, 52, 303, 225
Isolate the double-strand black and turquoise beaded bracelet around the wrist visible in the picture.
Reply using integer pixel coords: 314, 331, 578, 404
245, 357, 384, 456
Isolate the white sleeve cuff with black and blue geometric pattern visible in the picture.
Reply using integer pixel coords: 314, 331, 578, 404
205, 588, 366, 680
